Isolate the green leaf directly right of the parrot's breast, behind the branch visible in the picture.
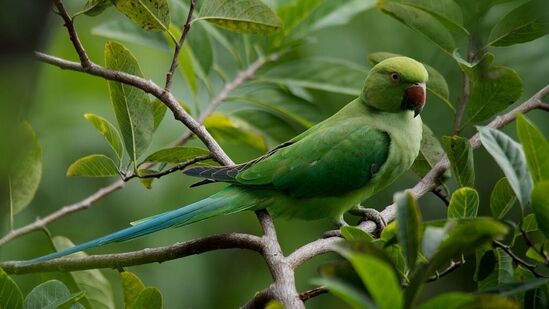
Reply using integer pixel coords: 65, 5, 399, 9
411, 124, 450, 182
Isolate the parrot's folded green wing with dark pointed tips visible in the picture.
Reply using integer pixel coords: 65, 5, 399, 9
185, 117, 390, 197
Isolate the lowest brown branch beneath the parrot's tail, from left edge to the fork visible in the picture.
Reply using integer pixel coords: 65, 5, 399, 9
0, 233, 263, 274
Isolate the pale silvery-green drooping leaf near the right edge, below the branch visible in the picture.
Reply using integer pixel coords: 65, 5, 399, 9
477, 127, 532, 208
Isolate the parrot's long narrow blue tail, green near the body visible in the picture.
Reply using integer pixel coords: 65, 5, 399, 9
21, 186, 260, 265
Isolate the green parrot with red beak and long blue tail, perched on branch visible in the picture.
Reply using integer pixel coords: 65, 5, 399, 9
23, 57, 428, 264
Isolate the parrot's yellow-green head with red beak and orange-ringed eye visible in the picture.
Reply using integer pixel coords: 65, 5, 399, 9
360, 57, 428, 117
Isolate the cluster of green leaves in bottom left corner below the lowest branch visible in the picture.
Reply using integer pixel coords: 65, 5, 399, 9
0, 260, 162, 309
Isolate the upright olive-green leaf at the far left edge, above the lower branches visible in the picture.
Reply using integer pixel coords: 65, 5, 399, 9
8, 122, 42, 216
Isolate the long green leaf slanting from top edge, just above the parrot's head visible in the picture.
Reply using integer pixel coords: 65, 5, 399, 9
377, 0, 456, 54
